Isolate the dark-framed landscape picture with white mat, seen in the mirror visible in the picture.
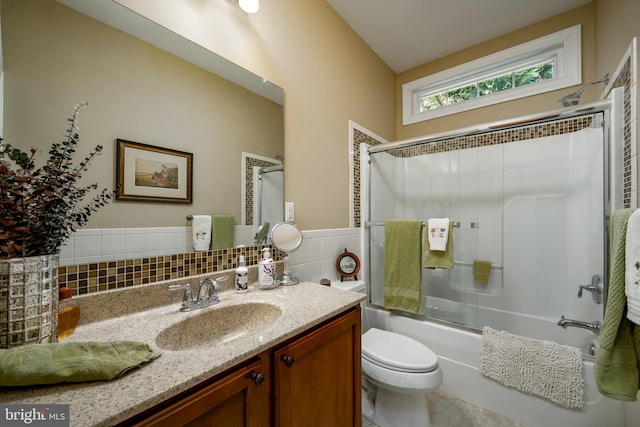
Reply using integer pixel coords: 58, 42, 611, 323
116, 139, 193, 203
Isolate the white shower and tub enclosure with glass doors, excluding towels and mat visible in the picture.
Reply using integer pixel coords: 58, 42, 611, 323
362, 98, 624, 427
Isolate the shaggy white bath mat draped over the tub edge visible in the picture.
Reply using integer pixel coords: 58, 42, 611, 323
478, 327, 584, 409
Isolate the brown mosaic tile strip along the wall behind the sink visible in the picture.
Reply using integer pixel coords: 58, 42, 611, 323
58, 245, 284, 295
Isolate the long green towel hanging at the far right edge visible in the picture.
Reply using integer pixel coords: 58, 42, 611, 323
593, 209, 640, 402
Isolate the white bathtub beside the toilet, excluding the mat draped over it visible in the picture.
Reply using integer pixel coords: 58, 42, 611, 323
363, 307, 624, 427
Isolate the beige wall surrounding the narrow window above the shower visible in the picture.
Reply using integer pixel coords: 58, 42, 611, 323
396, 3, 602, 140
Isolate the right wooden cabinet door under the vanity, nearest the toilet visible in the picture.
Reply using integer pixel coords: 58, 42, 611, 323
273, 306, 362, 427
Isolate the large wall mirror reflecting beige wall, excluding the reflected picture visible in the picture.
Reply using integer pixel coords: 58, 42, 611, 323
1, 0, 284, 260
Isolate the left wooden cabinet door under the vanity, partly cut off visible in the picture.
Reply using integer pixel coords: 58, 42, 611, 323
134, 358, 269, 427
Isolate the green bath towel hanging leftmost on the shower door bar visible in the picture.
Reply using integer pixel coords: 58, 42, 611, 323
384, 220, 422, 313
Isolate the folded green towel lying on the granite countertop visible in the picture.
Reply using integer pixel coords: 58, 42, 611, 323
0, 341, 160, 387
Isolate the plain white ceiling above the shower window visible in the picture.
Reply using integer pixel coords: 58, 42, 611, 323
327, 0, 592, 73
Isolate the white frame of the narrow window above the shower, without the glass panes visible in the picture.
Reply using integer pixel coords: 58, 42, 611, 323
402, 24, 582, 126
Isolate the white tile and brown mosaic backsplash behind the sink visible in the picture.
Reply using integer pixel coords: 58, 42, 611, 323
58, 227, 362, 295
